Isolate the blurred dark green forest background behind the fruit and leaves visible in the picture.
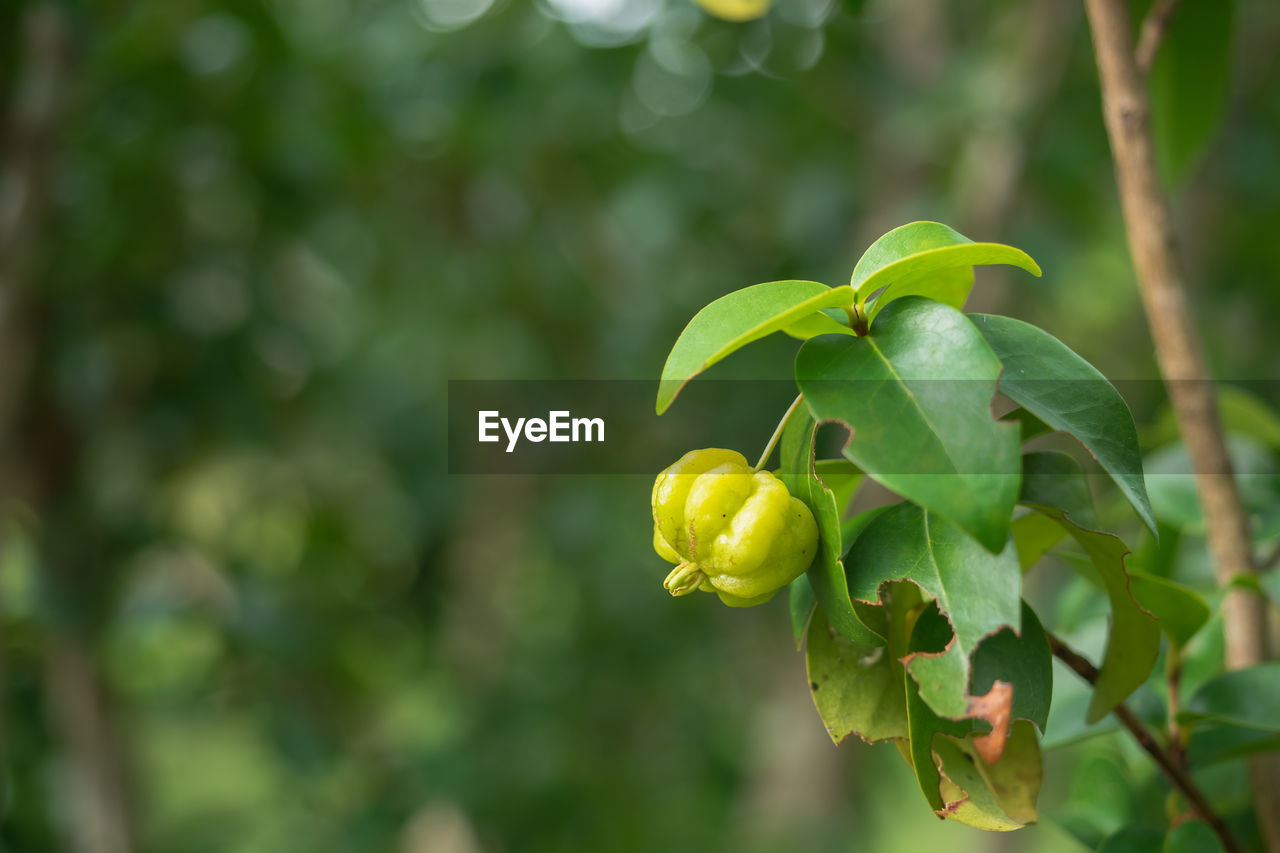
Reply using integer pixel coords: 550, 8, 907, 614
0, 0, 1280, 853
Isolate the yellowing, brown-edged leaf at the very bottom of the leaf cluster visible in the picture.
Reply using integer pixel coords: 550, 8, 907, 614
933, 720, 1043, 831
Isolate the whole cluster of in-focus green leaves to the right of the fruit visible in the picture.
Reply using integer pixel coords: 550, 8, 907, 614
659, 223, 1280, 835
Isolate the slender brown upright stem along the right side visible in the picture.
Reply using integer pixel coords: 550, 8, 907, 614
1084, 0, 1280, 852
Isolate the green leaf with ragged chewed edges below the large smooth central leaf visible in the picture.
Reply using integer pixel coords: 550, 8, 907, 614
845, 503, 1024, 725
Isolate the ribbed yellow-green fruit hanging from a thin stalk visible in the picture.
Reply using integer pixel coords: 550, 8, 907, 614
653, 448, 818, 607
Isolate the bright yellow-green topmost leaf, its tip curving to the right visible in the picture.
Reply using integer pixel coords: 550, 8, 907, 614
849, 222, 1041, 319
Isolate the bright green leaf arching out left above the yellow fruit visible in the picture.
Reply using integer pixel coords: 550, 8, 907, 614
657, 280, 854, 415
